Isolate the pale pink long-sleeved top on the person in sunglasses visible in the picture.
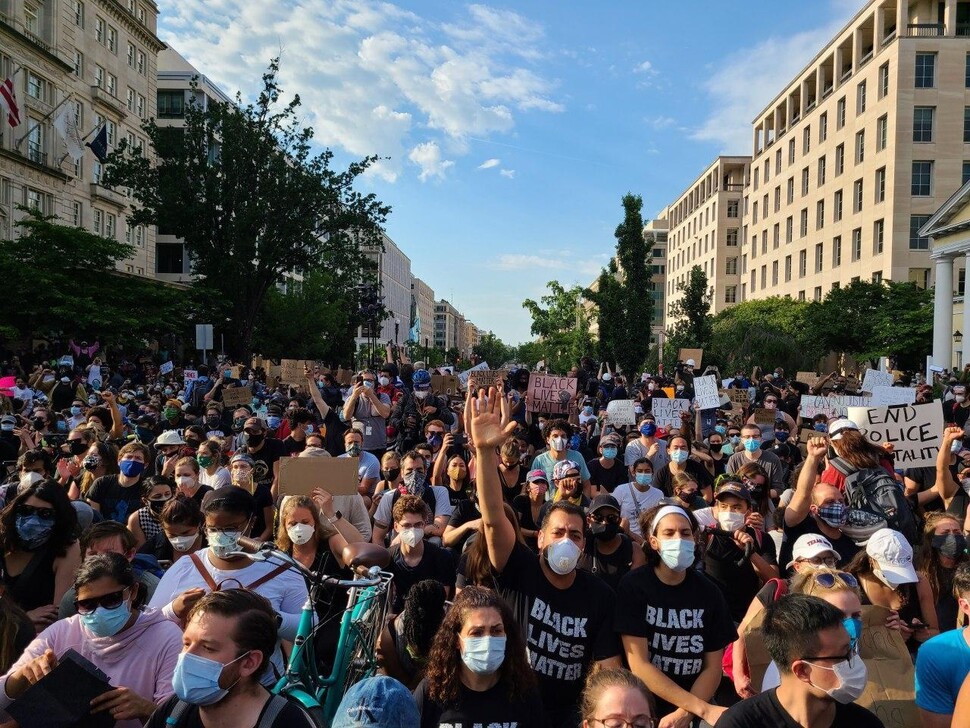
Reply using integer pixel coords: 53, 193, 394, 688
0, 609, 182, 728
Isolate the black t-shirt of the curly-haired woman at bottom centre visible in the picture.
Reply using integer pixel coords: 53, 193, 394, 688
414, 680, 549, 728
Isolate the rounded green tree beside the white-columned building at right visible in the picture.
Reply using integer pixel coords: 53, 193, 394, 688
810, 281, 933, 368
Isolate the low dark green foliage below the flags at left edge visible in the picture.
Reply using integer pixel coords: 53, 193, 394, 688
0, 208, 185, 345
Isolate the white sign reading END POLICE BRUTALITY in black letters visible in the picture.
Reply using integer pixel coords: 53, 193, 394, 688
848, 401, 943, 468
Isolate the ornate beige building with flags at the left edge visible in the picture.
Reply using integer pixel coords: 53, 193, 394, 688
0, 0, 165, 276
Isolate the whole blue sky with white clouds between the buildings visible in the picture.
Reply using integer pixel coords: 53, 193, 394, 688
158, 0, 865, 343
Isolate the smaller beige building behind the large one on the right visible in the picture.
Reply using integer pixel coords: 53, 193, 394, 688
664, 156, 751, 320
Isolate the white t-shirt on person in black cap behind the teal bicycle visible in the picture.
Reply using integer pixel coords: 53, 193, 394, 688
148, 549, 307, 681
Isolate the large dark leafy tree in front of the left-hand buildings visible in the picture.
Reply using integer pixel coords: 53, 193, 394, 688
104, 59, 390, 356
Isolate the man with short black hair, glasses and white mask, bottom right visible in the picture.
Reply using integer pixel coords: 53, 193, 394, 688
717, 594, 883, 728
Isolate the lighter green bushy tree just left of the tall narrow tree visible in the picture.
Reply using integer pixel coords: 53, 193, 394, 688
522, 281, 592, 373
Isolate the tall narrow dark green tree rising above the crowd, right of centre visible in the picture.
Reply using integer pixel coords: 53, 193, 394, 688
583, 194, 653, 372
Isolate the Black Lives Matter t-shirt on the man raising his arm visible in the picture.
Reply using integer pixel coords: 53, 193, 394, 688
498, 543, 620, 726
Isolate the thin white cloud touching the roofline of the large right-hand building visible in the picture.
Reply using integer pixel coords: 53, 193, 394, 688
691, 0, 860, 154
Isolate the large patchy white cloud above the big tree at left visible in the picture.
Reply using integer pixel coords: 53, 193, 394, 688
159, 0, 564, 181
